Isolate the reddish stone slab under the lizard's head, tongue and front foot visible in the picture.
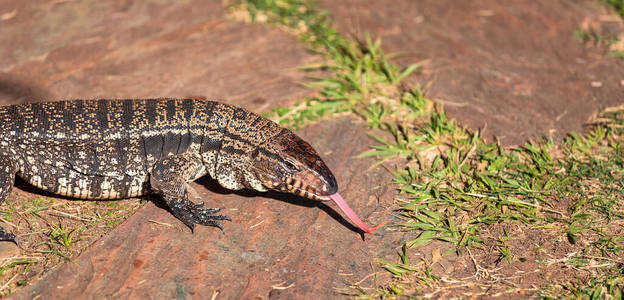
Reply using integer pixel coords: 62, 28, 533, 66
16, 118, 404, 299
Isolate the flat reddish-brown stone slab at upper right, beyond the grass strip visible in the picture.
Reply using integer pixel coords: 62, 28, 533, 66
320, 0, 624, 144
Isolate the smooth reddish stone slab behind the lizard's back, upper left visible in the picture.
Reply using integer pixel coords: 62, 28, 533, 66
0, 0, 317, 111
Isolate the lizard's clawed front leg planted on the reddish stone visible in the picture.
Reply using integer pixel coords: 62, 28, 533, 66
150, 153, 231, 231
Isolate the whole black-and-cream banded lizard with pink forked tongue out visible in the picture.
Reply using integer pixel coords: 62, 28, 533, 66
0, 99, 376, 241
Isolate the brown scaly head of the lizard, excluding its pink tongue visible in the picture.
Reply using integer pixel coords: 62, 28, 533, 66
250, 129, 338, 200
